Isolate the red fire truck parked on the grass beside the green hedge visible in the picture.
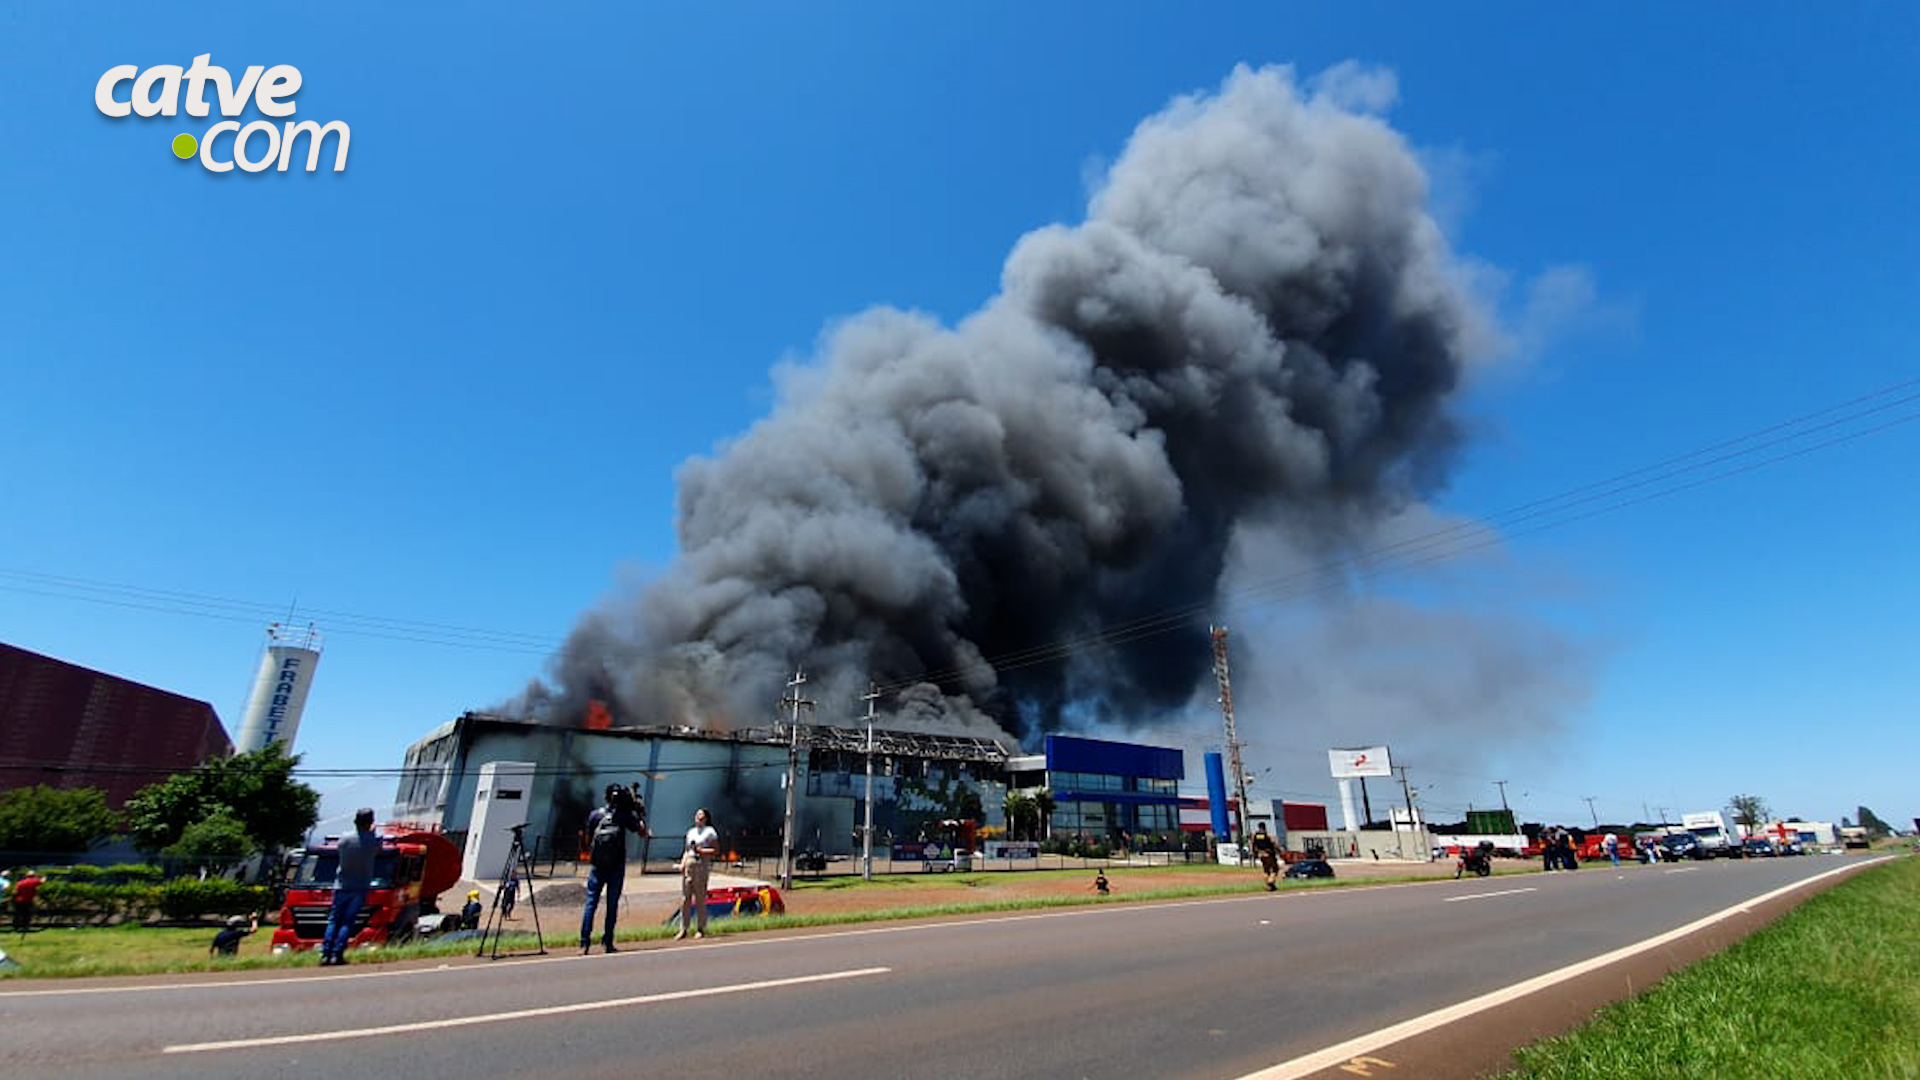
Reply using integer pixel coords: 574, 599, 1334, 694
273, 824, 461, 953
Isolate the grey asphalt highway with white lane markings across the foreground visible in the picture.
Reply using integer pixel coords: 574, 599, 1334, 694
0, 857, 1859, 1080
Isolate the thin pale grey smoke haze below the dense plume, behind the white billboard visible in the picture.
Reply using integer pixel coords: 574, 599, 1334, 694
1154, 505, 1609, 807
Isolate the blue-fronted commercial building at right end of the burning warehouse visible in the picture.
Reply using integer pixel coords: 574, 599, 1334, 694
1006, 734, 1187, 840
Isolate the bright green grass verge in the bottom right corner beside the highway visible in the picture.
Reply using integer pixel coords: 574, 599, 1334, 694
1505, 859, 1920, 1080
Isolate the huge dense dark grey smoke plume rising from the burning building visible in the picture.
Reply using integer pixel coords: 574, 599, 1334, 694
526, 67, 1494, 736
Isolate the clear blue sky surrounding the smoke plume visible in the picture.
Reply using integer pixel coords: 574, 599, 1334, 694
0, 4, 1920, 826
